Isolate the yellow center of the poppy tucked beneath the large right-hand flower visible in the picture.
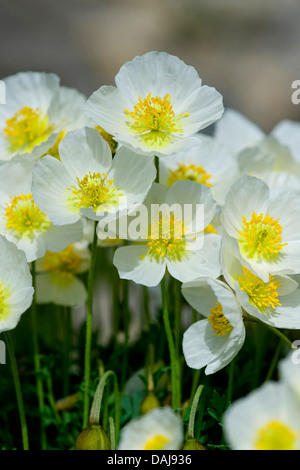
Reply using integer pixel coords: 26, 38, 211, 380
238, 267, 281, 313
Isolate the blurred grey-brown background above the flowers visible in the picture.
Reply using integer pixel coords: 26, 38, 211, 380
0, 0, 300, 132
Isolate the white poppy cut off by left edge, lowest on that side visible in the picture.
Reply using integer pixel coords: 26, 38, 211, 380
0, 235, 33, 333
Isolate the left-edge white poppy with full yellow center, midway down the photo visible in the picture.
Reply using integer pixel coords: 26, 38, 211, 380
0, 160, 82, 262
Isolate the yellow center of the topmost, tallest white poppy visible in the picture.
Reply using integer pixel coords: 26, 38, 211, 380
124, 93, 189, 147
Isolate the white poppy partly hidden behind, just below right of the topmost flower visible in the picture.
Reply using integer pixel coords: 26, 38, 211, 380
159, 135, 238, 205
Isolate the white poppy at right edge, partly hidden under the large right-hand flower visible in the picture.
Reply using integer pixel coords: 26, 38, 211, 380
221, 236, 300, 329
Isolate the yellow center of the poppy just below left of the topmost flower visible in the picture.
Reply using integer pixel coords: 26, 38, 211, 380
68, 172, 122, 211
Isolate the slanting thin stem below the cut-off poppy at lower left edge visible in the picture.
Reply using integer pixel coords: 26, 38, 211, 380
3, 331, 29, 450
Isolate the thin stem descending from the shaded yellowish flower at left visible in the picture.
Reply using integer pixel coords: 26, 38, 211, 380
31, 261, 47, 450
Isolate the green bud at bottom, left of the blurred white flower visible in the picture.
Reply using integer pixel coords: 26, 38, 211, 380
75, 424, 110, 450
